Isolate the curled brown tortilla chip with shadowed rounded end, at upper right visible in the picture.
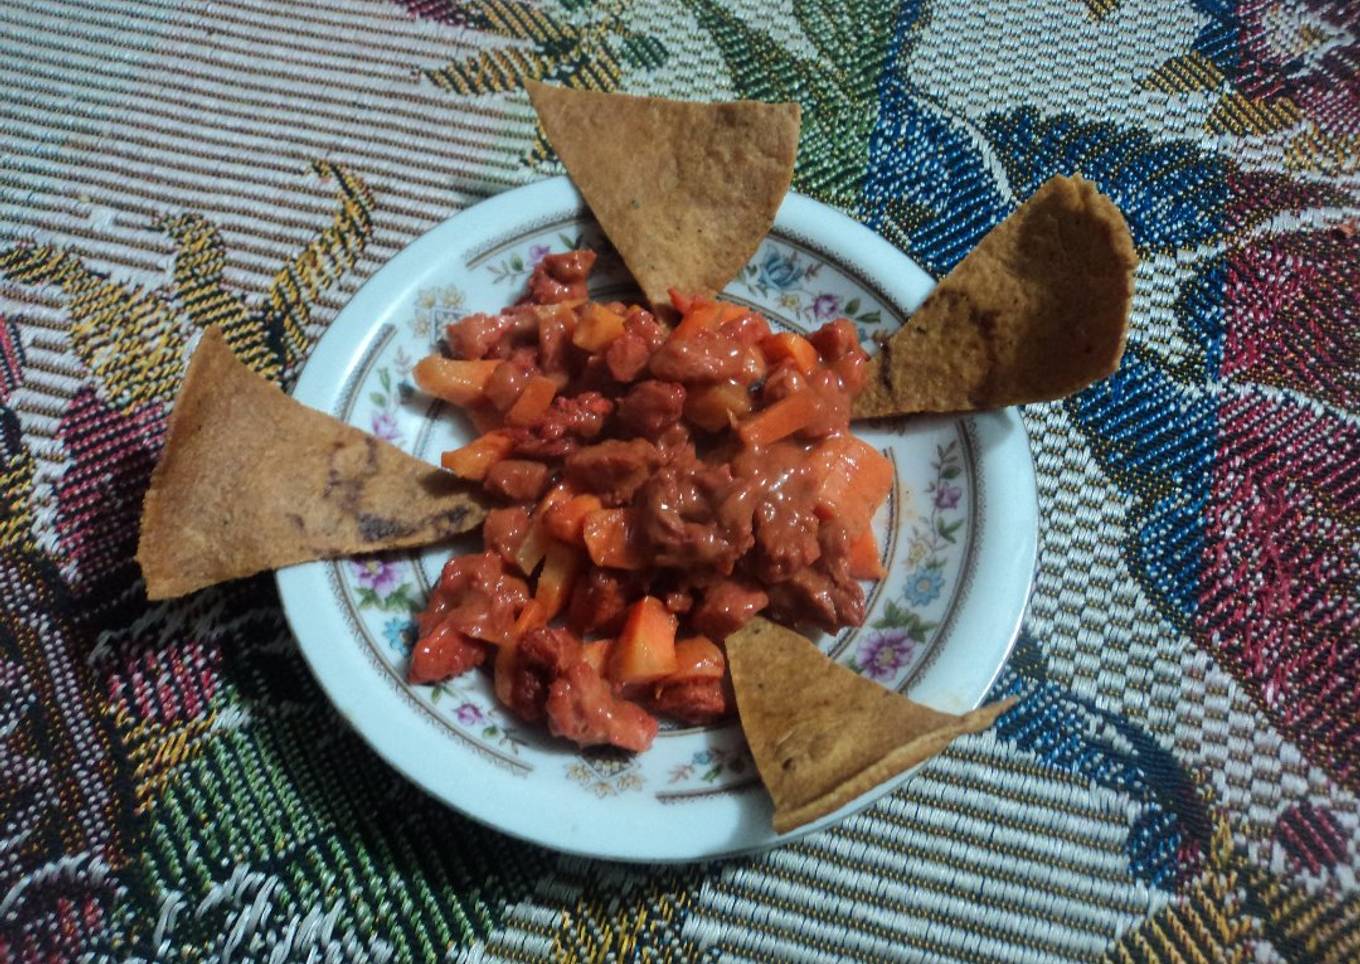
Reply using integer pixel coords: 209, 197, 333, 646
854, 177, 1138, 419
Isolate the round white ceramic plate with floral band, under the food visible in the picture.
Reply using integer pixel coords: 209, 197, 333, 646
279, 177, 1036, 862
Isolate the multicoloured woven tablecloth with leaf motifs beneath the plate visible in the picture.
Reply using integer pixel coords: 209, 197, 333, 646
0, 0, 1360, 961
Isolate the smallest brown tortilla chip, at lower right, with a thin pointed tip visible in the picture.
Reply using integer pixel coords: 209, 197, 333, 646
728, 619, 1013, 833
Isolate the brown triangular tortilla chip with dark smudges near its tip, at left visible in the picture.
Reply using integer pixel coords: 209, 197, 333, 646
137, 326, 486, 600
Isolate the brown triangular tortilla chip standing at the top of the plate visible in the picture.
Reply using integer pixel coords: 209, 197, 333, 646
526, 83, 800, 306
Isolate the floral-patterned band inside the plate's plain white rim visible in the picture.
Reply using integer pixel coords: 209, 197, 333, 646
325, 222, 971, 795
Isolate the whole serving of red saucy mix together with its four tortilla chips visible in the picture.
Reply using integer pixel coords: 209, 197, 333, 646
137, 78, 1137, 832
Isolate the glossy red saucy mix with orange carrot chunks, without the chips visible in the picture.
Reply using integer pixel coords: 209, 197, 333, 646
408, 250, 894, 751
